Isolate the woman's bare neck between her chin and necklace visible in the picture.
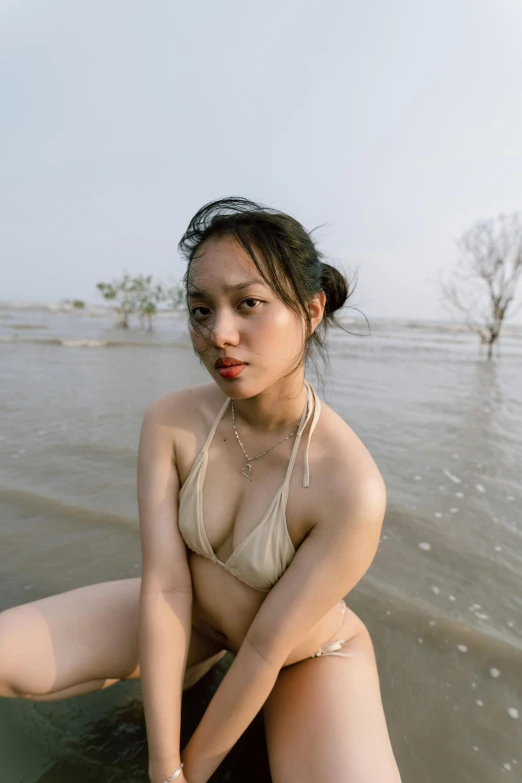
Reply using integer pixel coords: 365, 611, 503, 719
230, 373, 306, 433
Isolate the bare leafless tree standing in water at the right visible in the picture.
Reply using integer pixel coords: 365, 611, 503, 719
439, 212, 522, 359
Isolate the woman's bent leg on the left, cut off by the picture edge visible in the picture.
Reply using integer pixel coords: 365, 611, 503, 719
0, 578, 224, 701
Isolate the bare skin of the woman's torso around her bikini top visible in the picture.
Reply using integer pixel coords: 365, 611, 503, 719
170, 383, 377, 665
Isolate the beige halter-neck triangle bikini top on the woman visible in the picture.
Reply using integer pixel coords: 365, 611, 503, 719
178, 380, 321, 593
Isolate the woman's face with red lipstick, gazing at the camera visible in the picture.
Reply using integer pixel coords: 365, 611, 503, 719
188, 237, 310, 399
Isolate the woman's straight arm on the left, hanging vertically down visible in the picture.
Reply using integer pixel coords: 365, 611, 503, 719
137, 396, 192, 783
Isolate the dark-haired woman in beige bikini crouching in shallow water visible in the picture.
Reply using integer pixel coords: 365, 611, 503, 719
0, 198, 400, 783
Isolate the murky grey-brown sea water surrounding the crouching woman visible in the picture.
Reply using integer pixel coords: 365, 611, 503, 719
0, 303, 522, 783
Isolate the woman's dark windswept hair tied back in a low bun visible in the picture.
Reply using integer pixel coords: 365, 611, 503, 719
178, 196, 364, 388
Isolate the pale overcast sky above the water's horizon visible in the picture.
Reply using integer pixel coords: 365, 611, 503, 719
0, 0, 522, 321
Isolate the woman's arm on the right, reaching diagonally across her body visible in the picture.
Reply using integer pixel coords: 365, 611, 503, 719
182, 474, 386, 783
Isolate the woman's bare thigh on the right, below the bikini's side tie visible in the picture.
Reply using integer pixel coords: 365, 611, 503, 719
263, 628, 400, 783
